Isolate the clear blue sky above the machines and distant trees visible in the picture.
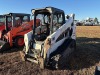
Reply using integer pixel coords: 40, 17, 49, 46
0, 0, 100, 21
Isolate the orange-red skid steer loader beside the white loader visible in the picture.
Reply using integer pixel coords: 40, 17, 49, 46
0, 13, 39, 52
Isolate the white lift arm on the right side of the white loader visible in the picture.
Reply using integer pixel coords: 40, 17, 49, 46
44, 14, 76, 58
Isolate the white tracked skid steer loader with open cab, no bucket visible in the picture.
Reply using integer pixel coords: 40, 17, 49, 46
20, 7, 76, 69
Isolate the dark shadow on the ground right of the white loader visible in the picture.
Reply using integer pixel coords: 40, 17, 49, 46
66, 37, 100, 70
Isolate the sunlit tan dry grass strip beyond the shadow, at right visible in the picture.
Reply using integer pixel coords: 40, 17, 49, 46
76, 26, 100, 38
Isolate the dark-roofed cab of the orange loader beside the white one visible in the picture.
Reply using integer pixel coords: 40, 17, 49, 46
4, 13, 30, 31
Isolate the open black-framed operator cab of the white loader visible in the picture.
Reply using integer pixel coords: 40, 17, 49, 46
32, 7, 65, 41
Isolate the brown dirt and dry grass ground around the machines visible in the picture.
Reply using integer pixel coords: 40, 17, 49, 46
0, 26, 100, 75
